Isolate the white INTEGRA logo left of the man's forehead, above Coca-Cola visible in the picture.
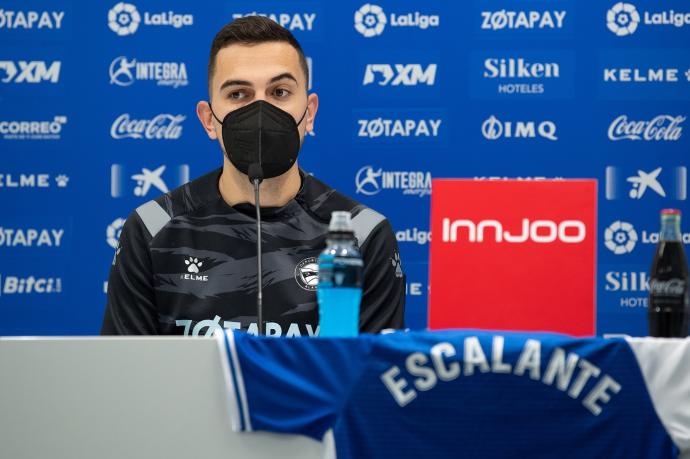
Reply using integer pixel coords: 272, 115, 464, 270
109, 56, 189, 88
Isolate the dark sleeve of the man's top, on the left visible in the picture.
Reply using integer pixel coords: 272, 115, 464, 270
101, 211, 158, 335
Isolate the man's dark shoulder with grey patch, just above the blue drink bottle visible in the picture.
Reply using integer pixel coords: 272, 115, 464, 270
297, 175, 388, 245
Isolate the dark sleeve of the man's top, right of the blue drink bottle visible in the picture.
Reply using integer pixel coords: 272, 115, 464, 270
359, 220, 405, 333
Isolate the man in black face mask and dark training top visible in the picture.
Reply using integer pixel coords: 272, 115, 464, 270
101, 16, 405, 336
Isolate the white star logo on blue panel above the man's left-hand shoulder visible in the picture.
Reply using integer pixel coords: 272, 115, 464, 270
110, 164, 189, 198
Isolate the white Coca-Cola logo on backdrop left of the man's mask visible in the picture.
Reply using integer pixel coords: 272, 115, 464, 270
110, 113, 187, 140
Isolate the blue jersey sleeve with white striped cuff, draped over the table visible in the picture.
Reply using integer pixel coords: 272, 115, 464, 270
215, 330, 371, 440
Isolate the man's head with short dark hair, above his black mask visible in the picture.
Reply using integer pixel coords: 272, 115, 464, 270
197, 16, 318, 171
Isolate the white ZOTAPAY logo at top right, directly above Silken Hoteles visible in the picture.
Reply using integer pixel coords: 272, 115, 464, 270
480, 9, 568, 31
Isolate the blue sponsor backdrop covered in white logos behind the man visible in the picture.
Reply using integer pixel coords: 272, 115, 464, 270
0, 0, 690, 335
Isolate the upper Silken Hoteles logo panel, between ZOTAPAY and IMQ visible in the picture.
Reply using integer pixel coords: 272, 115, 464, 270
471, 51, 574, 99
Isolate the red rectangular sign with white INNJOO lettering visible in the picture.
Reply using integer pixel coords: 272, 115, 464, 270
429, 179, 597, 336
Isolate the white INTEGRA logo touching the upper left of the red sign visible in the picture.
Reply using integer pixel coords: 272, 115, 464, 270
355, 166, 431, 197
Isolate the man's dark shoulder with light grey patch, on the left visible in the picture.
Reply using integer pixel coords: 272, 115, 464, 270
132, 169, 221, 238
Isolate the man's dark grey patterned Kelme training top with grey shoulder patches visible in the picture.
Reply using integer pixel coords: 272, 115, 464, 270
101, 169, 405, 336
